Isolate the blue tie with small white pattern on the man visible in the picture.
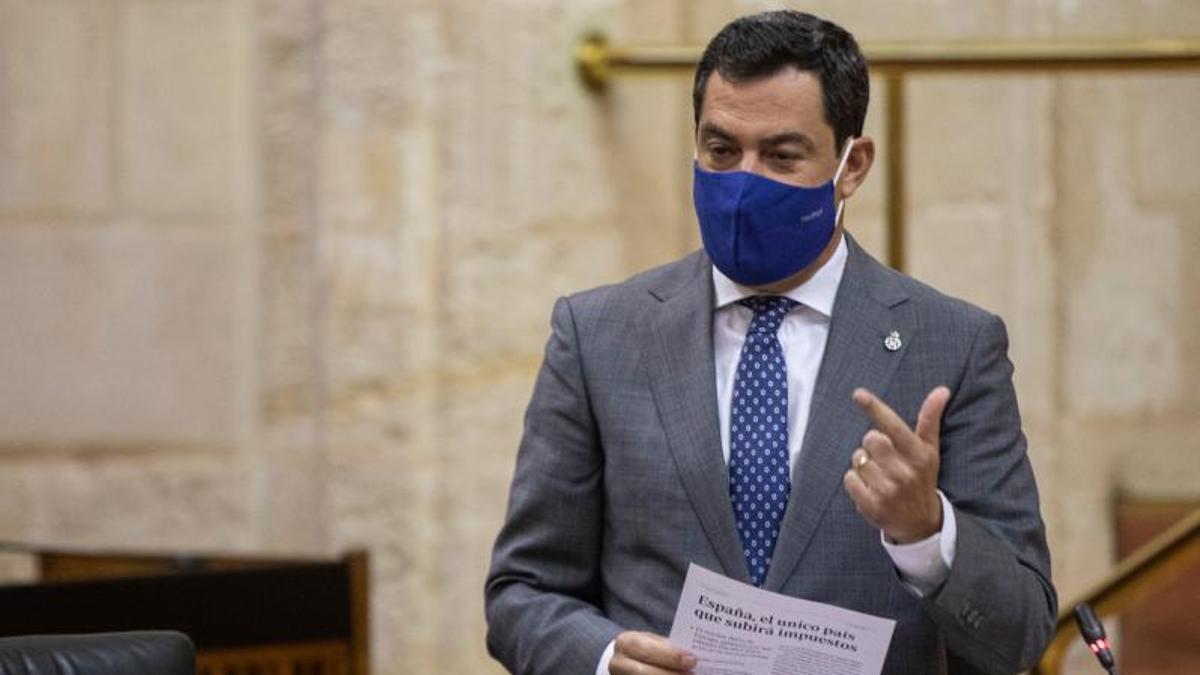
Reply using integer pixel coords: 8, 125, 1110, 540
730, 295, 797, 586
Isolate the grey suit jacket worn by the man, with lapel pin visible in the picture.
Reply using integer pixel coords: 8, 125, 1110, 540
486, 234, 1056, 675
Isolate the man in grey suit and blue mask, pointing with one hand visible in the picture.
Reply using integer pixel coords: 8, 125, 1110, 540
486, 11, 1056, 675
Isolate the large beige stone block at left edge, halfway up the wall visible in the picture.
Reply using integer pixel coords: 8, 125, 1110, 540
0, 223, 239, 446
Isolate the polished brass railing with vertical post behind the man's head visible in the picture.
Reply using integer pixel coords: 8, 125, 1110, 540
575, 35, 1200, 270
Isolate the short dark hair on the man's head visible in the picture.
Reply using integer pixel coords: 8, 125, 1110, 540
691, 10, 870, 148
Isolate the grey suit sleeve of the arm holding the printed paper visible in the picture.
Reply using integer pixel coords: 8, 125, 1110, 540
485, 299, 620, 675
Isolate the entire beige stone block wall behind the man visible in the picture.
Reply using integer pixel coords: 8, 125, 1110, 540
0, 0, 1200, 674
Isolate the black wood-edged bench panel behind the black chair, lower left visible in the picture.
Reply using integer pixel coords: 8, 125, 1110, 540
0, 550, 370, 675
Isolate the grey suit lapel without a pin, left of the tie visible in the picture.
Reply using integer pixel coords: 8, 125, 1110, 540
646, 253, 749, 581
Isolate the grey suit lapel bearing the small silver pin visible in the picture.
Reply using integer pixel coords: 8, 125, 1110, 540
764, 235, 916, 590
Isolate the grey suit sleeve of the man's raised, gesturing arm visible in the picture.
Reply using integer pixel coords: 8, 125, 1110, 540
922, 316, 1057, 673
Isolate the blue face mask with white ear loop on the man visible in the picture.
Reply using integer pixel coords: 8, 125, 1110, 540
692, 141, 852, 286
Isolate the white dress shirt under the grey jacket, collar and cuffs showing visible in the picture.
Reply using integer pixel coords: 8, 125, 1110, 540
596, 237, 958, 675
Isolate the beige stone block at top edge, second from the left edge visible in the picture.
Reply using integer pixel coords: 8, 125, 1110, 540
114, 0, 254, 221
